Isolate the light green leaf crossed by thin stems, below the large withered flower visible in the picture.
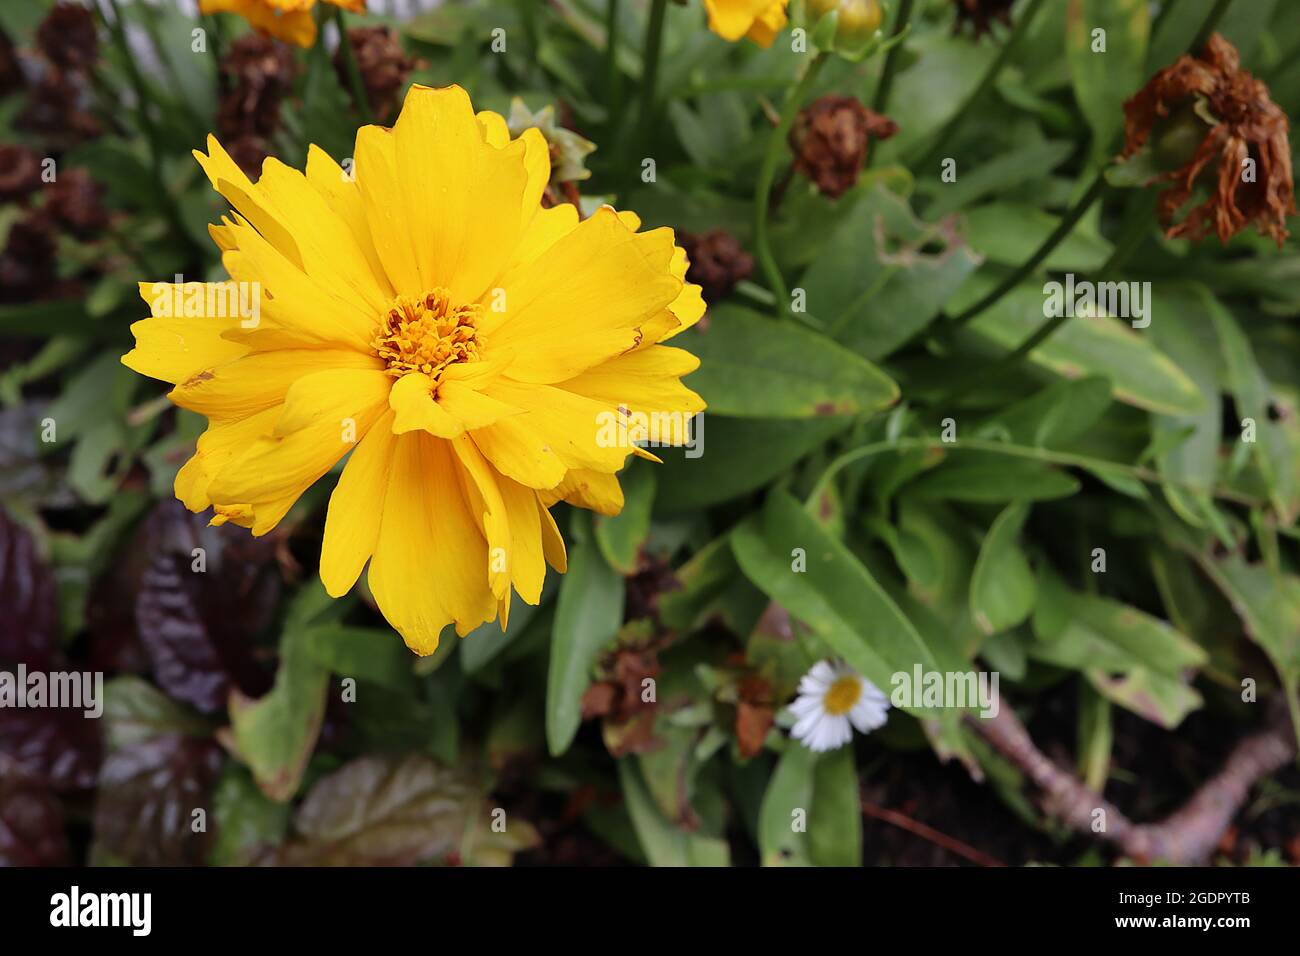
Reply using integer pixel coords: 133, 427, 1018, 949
952, 273, 1206, 415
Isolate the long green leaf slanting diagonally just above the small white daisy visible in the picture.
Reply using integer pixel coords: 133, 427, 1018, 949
732, 490, 954, 717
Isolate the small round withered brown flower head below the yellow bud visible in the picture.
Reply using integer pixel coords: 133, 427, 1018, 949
790, 96, 898, 199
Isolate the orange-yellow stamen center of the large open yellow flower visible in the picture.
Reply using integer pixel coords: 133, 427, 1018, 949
371, 289, 482, 380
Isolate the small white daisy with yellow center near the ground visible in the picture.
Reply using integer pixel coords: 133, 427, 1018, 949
789, 661, 889, 753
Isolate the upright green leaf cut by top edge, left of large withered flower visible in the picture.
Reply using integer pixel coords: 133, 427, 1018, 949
1065, 0, 1151, 159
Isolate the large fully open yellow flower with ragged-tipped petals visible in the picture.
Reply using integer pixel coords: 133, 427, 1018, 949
122, 86, 705, 654
